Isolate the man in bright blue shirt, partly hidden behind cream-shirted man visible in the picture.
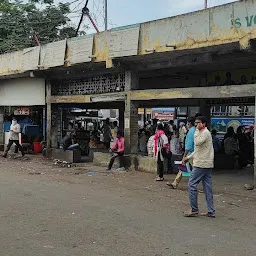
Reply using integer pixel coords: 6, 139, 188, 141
167, 117, 196, 189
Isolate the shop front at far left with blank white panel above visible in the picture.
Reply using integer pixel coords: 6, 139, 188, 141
0, 78, 45, 149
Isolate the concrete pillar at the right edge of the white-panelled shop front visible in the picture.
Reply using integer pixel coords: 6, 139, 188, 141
46, 81, 58, 149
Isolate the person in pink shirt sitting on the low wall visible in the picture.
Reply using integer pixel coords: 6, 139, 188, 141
107, 130, 124, 171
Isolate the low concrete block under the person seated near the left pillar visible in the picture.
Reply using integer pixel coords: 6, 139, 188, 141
46, 148, 81, 163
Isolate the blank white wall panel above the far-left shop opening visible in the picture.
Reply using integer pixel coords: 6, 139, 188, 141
0, 78, 45, 106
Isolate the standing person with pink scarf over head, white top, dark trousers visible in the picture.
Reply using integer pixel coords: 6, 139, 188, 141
154, 123, 170, 181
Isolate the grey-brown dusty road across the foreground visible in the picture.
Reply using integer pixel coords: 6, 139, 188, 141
0, 160, 256, 256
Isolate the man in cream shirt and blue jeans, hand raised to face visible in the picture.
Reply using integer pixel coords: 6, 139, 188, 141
183, 116, 215, 217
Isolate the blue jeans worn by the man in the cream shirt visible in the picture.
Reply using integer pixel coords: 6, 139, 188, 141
188, 167, 215, 214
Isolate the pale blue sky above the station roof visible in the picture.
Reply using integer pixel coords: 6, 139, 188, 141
68, 0, 236, 33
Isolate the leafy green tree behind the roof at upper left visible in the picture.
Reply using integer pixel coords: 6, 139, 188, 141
0, 0, 80, 53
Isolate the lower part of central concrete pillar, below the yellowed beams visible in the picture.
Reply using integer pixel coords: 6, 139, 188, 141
124, 97, 138, 154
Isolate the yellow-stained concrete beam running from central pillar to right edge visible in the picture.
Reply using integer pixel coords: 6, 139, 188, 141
131, 84, 256, 101
